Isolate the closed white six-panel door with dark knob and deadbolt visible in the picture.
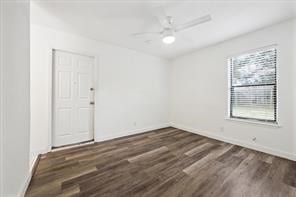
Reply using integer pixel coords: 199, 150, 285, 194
52, 50, 94, 147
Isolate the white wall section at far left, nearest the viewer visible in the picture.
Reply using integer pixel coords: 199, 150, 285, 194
0, 1, 30, 197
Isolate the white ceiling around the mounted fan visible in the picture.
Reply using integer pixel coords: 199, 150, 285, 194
31, 0, 296, 59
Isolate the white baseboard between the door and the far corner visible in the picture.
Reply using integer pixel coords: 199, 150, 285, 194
95, 123, 170, 142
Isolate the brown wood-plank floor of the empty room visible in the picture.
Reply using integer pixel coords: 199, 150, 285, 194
26, 128, 296, 197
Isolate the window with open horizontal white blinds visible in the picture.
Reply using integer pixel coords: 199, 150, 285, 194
228, 48, 277, 123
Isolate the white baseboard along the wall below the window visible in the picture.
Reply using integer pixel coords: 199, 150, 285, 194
170, 123, 296, 161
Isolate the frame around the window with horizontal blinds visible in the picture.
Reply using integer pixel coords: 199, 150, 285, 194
227, 44, 279, 125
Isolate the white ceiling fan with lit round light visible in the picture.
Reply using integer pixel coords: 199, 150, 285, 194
132, 8, 212, 44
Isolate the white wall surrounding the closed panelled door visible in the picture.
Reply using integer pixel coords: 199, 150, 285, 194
31, 25, 169, 164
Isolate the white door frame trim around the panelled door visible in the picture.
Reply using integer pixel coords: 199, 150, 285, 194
47, 47, 99, 152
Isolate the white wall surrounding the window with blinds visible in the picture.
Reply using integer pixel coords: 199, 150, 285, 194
170, 18, 296, 158
